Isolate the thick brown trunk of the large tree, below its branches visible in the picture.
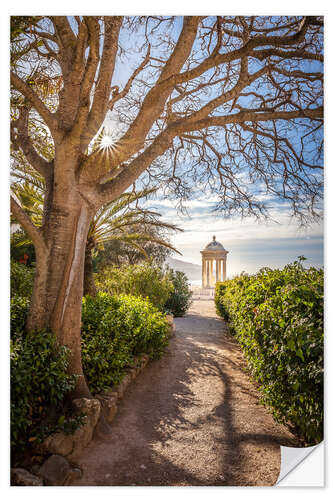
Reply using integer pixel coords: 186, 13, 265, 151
27, 186, 93, 397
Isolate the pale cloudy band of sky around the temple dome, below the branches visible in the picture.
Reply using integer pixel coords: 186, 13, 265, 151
147, 194, 323, 278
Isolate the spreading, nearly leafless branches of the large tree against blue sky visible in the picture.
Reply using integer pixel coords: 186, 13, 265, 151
12, 16, 323, 227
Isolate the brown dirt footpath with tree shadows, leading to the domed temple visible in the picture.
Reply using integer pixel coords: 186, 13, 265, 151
73, 300, 297, 486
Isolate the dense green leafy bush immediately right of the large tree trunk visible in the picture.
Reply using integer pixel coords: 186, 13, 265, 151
82, 292, 168, 392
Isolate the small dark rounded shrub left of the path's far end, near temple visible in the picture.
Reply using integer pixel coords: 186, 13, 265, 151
165, 269, 192, 317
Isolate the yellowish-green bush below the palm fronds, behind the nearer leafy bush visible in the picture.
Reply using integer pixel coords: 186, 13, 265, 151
96, 263, 173, 311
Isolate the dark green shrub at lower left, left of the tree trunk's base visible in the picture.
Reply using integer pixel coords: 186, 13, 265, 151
10, 331, 80, 456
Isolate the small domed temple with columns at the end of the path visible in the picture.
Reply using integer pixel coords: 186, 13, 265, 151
200, 236, 229, 288
